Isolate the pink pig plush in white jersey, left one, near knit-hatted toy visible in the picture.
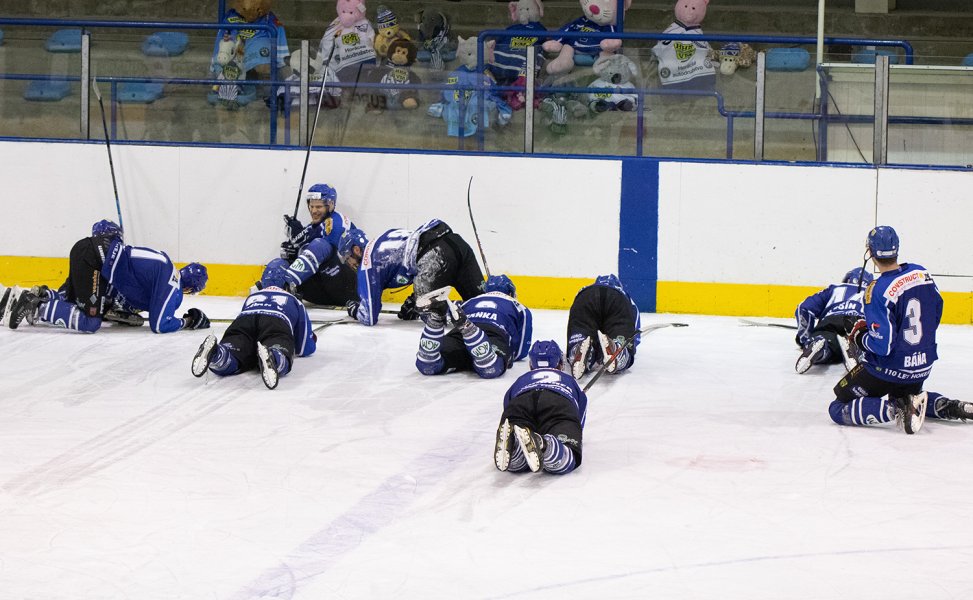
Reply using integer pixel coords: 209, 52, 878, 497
318, 0, 376, 82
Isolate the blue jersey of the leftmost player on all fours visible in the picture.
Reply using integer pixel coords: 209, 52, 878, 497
101, 239, 182, 333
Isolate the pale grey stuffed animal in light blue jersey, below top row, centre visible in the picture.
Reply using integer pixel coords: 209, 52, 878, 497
427, 37, 513, 137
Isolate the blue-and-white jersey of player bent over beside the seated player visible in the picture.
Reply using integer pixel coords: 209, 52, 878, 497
355, 219, 440, 325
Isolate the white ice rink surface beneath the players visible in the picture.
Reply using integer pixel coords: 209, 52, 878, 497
0, 297, 973, 600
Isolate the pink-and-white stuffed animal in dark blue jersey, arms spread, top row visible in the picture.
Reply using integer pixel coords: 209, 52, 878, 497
544, 0, 632, 75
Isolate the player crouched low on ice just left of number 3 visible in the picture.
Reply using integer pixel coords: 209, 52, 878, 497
794, 268, 874, 373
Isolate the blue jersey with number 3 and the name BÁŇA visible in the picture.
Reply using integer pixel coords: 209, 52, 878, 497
863, 263, 943, 383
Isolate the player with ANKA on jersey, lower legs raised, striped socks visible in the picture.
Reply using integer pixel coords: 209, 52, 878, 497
416, 275, 533, 379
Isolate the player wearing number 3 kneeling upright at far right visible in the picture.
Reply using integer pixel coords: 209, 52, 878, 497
829, 225, 973, 434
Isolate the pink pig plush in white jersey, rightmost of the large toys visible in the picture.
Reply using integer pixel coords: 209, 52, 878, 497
652, 0, 716, 89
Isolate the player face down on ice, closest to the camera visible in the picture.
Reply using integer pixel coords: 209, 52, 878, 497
493, 341, 588, 475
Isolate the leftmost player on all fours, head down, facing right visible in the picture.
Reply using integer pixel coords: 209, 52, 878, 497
5, 221, 209, 333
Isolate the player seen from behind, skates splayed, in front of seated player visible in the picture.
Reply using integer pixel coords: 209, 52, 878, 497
192, 266, 317, 389
